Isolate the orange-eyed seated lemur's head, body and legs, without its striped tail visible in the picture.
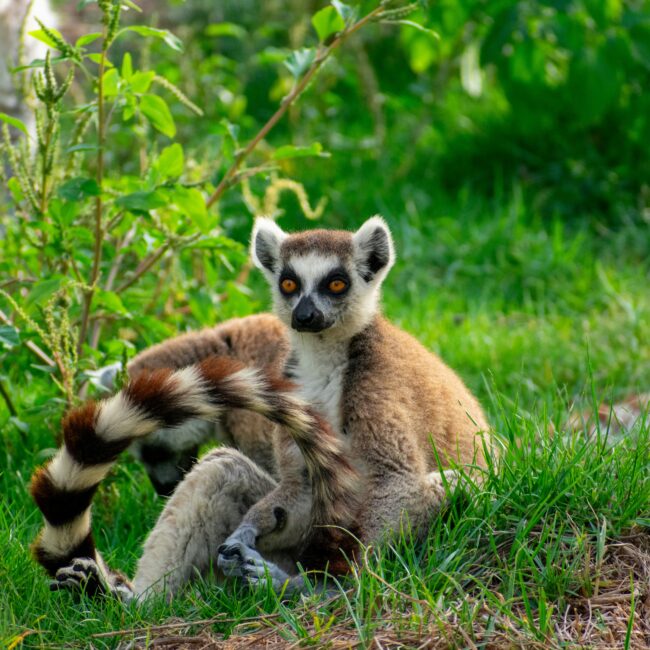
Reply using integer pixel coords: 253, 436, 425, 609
30, 217, 489, 595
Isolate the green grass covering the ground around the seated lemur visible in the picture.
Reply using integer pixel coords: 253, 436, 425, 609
0, 196, 650, 647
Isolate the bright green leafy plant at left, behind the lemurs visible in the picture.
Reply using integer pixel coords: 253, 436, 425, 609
0, 0, 416, 404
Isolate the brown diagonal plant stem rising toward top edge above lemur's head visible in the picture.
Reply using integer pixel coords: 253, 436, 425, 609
206, 5, 384, 208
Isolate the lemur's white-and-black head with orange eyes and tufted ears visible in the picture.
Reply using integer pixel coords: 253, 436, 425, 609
252, 217, 394, 335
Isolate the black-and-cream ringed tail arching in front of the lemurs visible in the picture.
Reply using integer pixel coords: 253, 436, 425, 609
31, 357, 356, 576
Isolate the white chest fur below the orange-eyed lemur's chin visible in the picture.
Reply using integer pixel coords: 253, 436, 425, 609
288, 335, 349, 435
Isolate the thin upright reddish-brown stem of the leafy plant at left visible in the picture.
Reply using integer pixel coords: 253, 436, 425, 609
77, 40, 108, 355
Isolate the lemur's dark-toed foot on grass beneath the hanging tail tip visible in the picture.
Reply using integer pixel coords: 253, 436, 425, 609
50, 557, 134, 602
